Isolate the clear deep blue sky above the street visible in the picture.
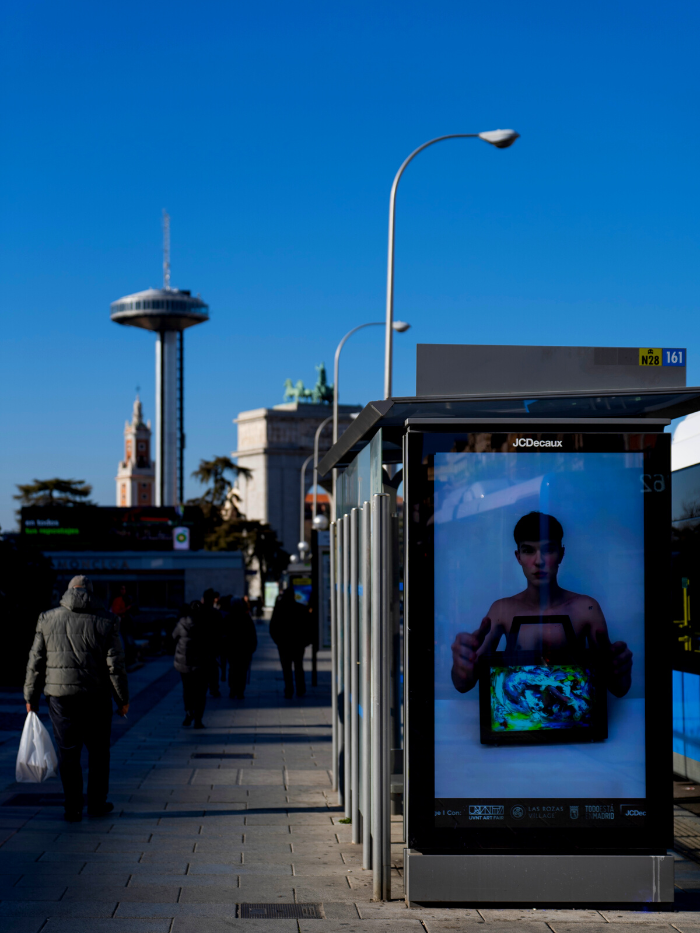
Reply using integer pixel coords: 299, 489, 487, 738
0, 0, 700, 528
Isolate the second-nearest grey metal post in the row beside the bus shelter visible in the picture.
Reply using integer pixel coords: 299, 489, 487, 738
360, 502, 372, 870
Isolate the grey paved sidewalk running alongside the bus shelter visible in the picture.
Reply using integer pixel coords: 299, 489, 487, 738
0, 626, 700, 933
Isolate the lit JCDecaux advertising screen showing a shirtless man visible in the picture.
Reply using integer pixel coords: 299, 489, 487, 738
407, 432, 670, 847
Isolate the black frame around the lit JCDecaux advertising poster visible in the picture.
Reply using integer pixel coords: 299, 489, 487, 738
405, 424, 673, 854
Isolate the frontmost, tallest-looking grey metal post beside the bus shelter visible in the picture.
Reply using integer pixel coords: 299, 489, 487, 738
371, 495, 391, 901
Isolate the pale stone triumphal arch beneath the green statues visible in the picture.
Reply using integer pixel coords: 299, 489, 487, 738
231, 402, 362, 554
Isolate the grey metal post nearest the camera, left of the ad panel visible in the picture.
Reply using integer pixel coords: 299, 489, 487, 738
371, 494, 388, 901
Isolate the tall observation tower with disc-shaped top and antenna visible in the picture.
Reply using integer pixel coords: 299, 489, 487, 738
110, 211, 209, 506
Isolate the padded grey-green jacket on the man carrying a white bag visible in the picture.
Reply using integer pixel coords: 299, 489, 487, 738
24, 588, 129, 706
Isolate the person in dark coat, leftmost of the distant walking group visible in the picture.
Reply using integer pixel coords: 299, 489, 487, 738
173, 602, 216, 729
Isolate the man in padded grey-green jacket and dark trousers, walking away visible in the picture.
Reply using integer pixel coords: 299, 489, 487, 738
24, 576, 129, 823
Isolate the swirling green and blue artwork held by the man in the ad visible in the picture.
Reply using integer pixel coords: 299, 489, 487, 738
490, 664, 594, 732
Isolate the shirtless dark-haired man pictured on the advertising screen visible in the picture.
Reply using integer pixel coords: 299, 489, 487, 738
452, 512, 632, 697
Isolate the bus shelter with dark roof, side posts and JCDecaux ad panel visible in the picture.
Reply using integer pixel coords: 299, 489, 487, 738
319, 376, 700, 905
